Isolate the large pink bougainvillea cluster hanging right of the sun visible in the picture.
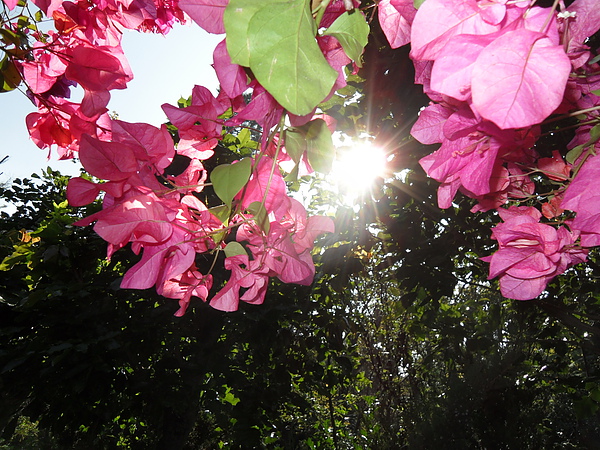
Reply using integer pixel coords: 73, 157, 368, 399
379, 0, 600, 300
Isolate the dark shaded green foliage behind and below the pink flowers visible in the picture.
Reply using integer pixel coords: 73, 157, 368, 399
0, 15, 600, 450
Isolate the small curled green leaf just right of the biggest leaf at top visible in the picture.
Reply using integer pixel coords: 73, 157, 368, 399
325, 10, 369, 67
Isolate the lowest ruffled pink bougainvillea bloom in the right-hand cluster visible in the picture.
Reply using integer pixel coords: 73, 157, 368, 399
482, 207, 586, 300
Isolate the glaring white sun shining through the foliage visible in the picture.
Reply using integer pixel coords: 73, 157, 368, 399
331, 141, 388, 197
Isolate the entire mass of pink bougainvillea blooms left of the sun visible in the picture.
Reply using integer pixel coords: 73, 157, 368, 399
5, 0, 376, 316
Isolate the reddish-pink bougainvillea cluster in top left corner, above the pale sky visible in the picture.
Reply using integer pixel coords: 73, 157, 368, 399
18, 0, 184, 159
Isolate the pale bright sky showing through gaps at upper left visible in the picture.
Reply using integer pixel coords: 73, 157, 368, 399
0, 22, 223, 183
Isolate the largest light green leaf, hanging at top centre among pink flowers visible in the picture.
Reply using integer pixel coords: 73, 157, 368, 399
224, 0, 337, 115
